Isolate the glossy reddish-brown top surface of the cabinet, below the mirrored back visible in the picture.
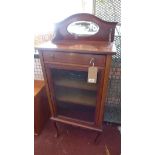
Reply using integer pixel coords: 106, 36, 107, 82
35, 40, 116, 54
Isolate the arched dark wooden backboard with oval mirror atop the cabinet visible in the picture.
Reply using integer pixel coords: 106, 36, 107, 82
52, 13, 117, 42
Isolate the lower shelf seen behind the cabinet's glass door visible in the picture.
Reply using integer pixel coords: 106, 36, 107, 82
56, 88, 96, 106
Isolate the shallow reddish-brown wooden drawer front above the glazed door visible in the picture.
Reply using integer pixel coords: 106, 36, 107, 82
43, 51, 105, 67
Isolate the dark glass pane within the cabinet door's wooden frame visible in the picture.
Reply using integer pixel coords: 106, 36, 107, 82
51, 69, 98, 122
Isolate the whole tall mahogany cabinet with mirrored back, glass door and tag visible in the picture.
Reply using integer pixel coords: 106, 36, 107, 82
35, 13, 117, 139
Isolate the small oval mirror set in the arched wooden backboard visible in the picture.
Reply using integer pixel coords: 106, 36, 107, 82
67, 21, 99, 36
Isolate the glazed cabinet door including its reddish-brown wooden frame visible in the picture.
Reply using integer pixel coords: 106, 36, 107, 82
45, 64, 103, 124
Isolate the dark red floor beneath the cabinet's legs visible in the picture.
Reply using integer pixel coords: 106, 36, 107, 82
34, 120, 121, 155
